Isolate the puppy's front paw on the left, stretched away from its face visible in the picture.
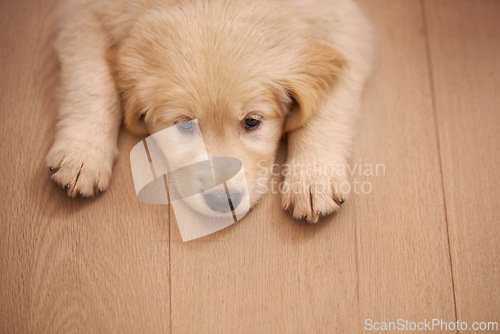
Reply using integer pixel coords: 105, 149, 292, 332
46, 140, 118, 197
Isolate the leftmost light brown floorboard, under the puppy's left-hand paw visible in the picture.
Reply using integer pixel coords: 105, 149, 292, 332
0, 1, 170, 333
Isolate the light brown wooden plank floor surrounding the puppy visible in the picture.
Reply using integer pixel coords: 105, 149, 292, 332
0, 0, 500, 333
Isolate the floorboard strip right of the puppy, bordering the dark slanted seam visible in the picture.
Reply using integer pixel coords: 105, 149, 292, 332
352, 0, 455, 333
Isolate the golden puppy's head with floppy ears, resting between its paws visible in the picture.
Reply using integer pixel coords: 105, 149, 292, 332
112, 1, 344, 214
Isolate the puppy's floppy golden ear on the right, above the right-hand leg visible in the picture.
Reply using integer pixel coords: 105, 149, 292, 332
284, 41, 346, 133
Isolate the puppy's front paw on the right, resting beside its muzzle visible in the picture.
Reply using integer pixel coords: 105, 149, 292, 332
281, 164, 348, 223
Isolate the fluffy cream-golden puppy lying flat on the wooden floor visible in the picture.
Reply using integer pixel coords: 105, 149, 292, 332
47, 0, 373, 223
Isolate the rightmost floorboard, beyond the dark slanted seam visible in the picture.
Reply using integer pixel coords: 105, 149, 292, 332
425, 0, 500, 324
